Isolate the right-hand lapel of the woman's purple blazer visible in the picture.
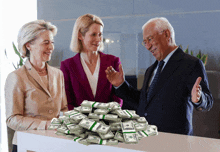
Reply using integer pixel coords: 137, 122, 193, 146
95, 52, 110, 99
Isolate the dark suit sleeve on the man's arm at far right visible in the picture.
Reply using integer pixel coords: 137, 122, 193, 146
188, 60, 213, 111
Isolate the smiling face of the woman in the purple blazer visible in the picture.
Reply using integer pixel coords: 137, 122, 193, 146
79, 23, 103, 51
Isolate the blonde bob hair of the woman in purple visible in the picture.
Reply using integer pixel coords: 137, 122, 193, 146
70, 14, 104, 53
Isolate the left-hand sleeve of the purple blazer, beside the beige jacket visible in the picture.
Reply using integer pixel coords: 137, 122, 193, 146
60, 62, 74, 110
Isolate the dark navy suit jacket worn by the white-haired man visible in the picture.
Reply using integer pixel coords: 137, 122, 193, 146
116, 48, 213, 135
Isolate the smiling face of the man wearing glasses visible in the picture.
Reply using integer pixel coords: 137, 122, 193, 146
143, 23, 169, 61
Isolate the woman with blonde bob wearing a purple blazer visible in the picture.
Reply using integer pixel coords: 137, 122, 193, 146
60, 14, 122, 110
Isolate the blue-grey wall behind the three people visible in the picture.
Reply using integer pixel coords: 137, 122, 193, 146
38, 0, 220, 75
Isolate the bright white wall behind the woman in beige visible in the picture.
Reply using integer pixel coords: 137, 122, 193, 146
0, 0, 37, 152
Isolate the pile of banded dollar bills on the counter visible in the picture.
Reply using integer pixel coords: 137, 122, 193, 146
48, 100, 158, 145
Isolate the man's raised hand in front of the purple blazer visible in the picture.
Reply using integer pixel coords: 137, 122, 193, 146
105, 64, 125, 87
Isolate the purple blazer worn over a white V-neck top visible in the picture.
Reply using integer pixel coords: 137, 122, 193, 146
60, 52, 123, 110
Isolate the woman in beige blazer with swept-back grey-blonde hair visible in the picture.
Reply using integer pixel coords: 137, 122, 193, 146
5, 20, 68, 152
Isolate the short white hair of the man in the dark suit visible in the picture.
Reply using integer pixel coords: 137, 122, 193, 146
142, 17, 175, 43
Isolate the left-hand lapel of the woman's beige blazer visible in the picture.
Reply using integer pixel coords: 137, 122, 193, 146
25, 60, 51, 97
